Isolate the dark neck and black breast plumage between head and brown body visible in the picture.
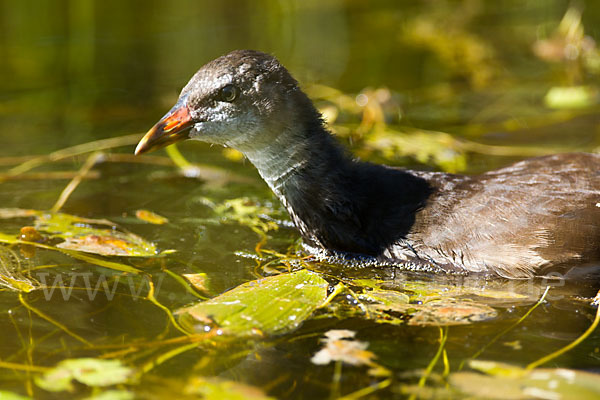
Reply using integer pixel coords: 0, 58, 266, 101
241, 92, 431, 256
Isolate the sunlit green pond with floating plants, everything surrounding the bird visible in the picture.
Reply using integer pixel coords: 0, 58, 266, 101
0, 0, 600, 399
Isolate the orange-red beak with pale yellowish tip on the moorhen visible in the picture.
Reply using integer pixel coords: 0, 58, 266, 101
135, 96, 192, 155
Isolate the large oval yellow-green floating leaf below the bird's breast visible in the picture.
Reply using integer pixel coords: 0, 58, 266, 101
179, 270, 327, 337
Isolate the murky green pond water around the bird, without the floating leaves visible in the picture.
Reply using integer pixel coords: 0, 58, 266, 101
0, 0, 600, 399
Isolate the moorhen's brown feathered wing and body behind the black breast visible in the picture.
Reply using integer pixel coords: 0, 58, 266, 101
398, 154, 600, 278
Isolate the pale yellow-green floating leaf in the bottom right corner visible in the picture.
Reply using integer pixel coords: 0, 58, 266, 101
450, 360, 600, 400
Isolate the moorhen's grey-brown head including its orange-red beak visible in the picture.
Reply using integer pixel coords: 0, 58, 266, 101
135, 50, 301, 154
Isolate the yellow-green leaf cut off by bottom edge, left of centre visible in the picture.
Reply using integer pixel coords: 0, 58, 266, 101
184, 377, 274, 400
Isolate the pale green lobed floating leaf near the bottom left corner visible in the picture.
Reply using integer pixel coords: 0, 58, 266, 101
35, 358, 133, 392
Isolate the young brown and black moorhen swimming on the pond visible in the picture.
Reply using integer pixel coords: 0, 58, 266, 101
135, 50, 600, 278
